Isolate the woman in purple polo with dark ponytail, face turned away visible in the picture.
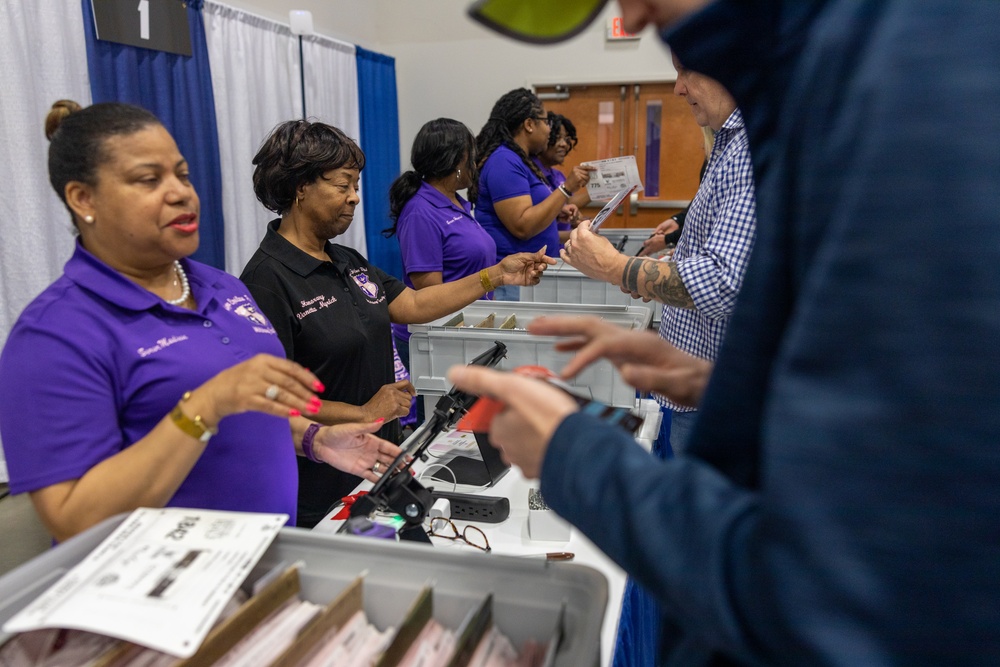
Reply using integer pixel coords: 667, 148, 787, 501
385, 118, 497, 384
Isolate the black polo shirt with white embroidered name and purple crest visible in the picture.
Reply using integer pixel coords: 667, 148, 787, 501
240, 220, 406, 527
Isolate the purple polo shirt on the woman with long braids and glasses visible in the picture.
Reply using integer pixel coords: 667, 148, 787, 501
476, 146, 559, 261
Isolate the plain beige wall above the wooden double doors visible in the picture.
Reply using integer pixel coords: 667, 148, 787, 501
220, 0, 676, 169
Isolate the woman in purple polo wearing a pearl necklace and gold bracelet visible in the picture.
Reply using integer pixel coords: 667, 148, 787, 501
0, 100, 399, 540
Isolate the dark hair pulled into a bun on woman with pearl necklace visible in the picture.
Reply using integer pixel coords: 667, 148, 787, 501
45, 100, 162, 211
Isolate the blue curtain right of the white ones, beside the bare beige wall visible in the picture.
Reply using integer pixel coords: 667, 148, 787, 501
357, 46, 403, 278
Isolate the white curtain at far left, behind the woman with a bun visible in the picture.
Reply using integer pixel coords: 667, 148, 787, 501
0, 0, 90, 482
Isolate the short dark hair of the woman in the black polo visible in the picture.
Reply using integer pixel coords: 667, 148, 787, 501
253, 120, 365, 215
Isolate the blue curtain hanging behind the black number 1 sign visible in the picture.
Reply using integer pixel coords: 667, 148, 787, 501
81, 0, 225, 270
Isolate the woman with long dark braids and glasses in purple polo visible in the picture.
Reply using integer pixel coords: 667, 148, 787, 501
475, 88, 593, 301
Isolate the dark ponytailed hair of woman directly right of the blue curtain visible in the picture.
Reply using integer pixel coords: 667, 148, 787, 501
382, 118, 476, 238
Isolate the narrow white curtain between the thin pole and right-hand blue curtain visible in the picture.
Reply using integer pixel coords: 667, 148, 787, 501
302, 35, 372, 256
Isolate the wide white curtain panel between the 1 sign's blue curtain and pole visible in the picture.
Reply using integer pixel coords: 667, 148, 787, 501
204, 1, 302, 276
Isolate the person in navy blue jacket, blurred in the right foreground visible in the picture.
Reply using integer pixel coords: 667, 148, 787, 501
452, 0, 1000, 665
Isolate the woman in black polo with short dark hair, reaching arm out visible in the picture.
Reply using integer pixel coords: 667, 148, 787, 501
240, 120, 554, 527
